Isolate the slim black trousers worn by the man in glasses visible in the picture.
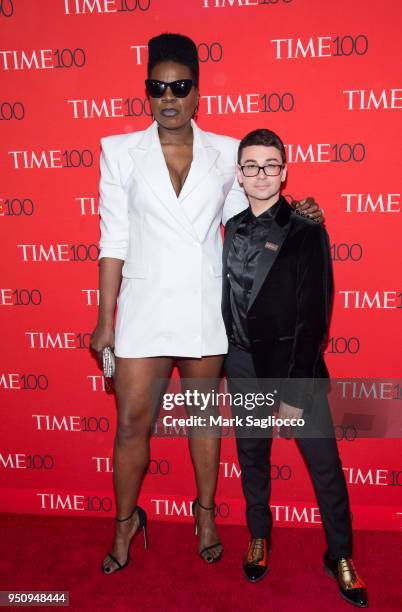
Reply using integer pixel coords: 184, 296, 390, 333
225, 345, 352, 559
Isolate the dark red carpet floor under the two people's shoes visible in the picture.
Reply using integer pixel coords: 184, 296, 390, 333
0, 514, 402, 612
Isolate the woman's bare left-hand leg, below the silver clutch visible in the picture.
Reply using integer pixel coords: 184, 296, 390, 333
103, 357, 173, 573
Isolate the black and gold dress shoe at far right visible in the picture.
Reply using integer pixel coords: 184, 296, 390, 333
324, 552, 368, 608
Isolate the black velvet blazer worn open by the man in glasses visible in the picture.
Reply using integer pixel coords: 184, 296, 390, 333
222, 197, 333, 411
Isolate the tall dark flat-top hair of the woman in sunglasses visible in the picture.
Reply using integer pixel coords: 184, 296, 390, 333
148, 34, 200, 87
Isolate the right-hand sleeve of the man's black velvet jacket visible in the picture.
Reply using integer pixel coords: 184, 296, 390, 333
283, 225, 333, 409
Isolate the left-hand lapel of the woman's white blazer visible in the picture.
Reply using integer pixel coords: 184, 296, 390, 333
128, 121, 198, 240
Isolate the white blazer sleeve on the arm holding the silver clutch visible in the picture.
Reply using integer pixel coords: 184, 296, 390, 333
99, 137, 129, 260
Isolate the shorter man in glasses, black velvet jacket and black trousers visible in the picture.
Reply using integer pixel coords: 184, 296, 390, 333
222, 130, 367, 607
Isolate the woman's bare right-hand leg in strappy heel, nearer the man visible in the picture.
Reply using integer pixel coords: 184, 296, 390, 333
177, 355, 224, 562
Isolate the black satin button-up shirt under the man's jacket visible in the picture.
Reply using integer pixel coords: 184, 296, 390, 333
227, 202, 279, 350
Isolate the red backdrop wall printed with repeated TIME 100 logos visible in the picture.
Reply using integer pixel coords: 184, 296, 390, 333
0, 0, 402, 530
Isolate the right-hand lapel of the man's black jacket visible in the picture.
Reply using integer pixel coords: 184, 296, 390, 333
247, 197, 291, 311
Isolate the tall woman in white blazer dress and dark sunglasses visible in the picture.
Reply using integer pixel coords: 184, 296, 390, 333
91, 34, 317, 573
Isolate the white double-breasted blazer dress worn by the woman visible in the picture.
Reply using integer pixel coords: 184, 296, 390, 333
99, 121, 248, 357
